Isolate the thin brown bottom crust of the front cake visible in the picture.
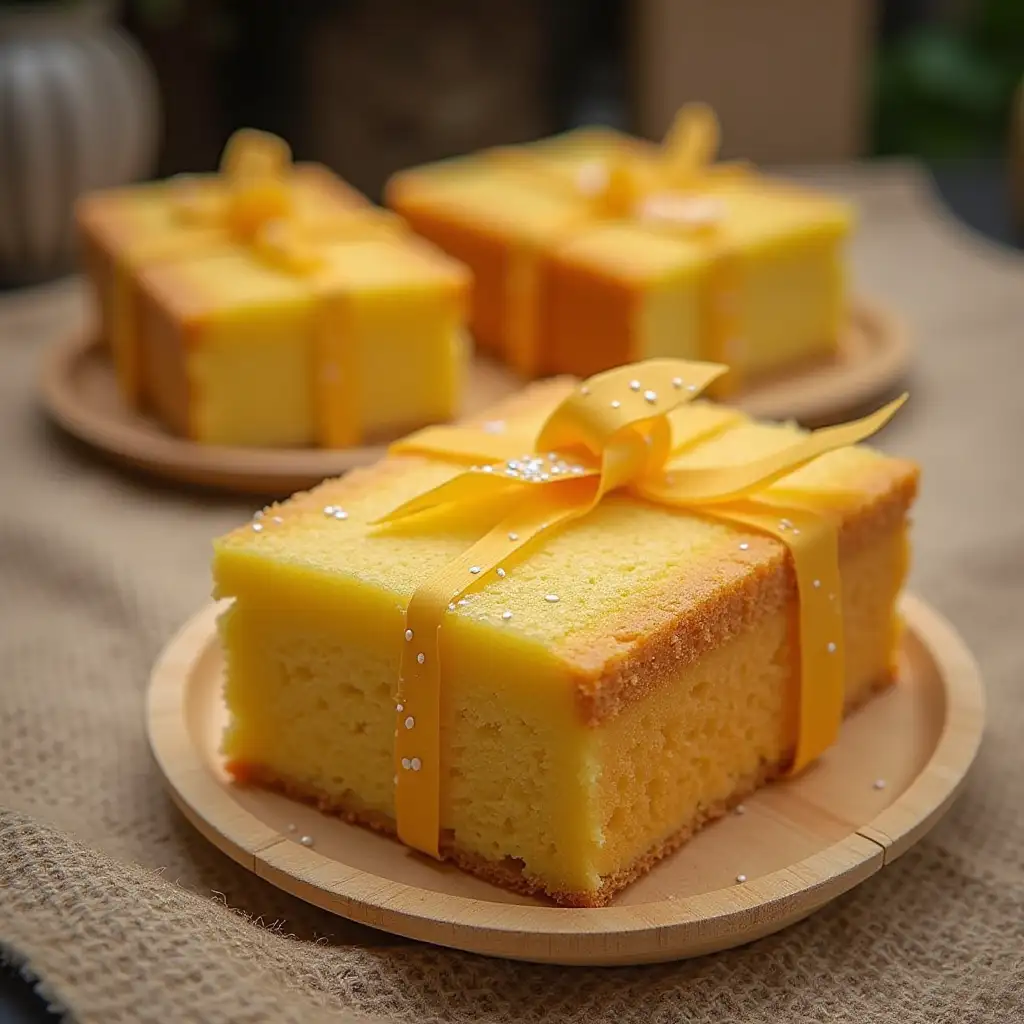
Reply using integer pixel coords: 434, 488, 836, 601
227, 673, 895, 907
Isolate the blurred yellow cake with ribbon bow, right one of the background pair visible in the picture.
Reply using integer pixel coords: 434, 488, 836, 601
386, 105, 852, 387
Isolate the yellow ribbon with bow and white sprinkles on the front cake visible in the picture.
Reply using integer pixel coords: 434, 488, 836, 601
378, 359, 906, 857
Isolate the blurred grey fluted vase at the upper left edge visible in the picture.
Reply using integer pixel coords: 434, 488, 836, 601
0, 0, 159, 285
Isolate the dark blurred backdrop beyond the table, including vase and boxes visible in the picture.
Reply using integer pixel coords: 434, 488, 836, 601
0, 0, 1024, 281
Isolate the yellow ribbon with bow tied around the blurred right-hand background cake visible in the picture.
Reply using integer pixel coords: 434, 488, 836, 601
496, 103, 751, 382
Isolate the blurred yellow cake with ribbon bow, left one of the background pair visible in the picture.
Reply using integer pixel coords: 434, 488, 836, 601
77, 131, 469, 447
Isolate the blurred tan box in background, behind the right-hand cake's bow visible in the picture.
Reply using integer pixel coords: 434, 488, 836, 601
631, 0, 876, 164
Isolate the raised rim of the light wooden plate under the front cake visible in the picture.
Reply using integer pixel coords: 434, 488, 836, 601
146, 594, 984, 964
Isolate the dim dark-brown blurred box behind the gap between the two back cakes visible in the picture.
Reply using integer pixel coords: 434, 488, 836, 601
300, 0, 553, 198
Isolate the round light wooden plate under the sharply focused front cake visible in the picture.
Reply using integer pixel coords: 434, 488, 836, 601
146, 596, 984, 964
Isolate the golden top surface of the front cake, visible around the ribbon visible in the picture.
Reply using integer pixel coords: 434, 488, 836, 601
215, 382, 915, 676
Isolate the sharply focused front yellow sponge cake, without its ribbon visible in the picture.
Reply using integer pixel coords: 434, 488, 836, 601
214, 366, 916, 906
